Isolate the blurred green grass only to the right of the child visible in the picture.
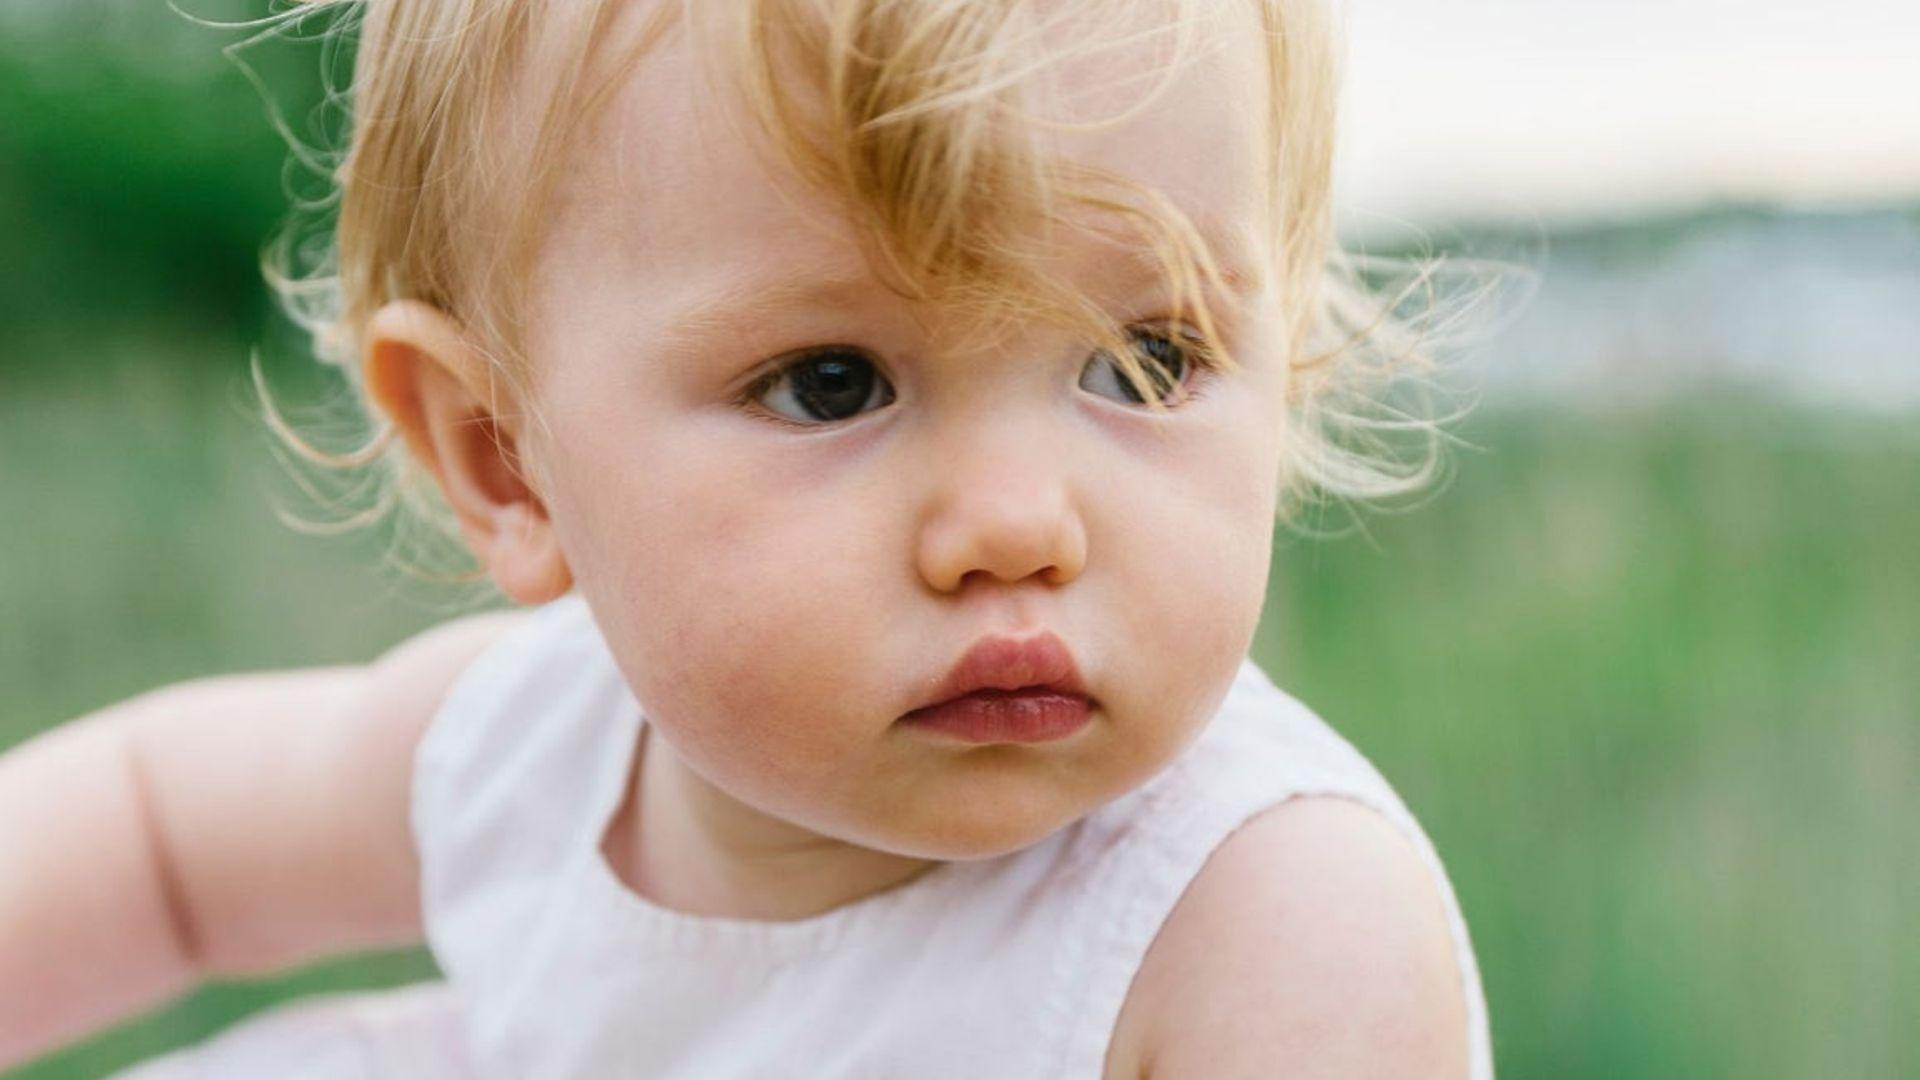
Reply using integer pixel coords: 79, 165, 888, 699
1263, 402, 1920, 1078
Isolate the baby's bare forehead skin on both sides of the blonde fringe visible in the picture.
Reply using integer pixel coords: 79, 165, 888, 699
540, 0, 1271, 328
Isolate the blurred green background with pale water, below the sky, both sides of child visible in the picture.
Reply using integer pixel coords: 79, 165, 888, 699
0, 0, 1920, 1080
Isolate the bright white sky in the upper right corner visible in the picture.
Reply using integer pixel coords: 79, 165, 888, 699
1340, 0, 1920, 221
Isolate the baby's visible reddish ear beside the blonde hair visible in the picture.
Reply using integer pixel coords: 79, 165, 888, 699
361, 300, 572, 603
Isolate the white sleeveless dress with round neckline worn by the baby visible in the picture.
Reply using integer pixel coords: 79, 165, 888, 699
112, 594, 1492, 1080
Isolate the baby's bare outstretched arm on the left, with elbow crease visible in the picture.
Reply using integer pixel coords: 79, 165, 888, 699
0, 613, 524, 1068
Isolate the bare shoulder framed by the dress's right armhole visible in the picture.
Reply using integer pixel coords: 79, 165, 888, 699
1108, 796, 1469, 1076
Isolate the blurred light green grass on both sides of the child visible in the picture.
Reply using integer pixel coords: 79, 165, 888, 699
0, 351, 1920, 1080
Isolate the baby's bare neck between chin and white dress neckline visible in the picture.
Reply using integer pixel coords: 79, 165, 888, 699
601, 724, 937, 920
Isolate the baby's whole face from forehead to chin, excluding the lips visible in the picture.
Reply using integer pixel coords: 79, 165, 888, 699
528, 6, 1286, 859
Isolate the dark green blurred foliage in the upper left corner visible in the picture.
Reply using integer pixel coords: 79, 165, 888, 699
0, 0, 340, 365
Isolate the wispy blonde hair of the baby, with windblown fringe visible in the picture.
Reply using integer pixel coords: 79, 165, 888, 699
224, 0, 1444, 578
